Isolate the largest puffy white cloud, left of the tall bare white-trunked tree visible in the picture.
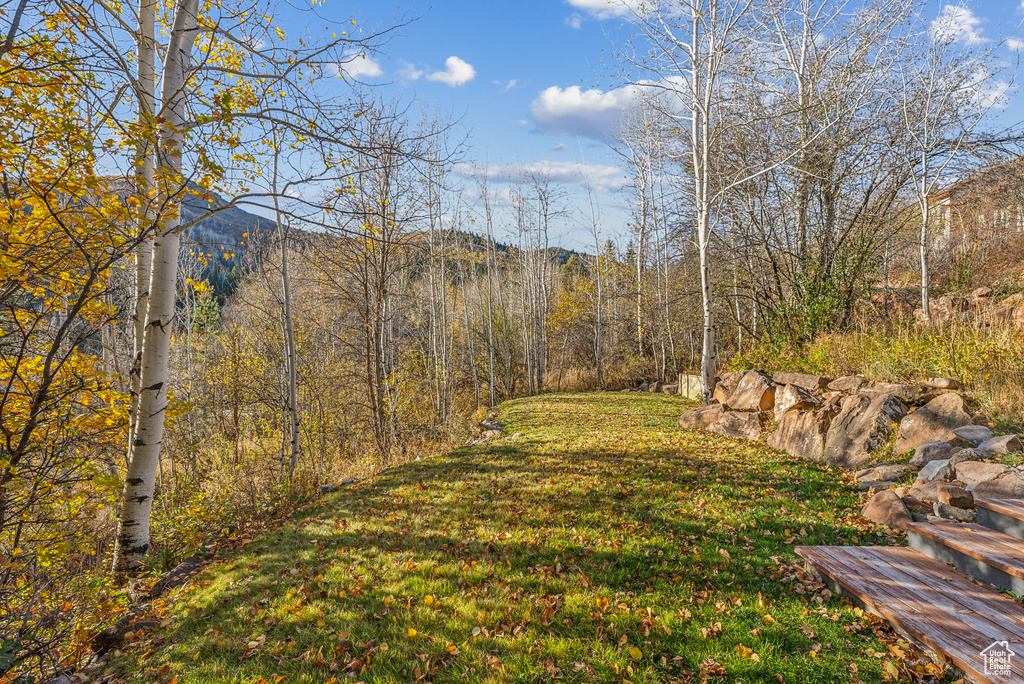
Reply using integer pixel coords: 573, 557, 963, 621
529, 86, 637, 140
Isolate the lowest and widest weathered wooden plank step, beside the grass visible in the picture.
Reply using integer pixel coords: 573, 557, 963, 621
797, 547, 1024, 684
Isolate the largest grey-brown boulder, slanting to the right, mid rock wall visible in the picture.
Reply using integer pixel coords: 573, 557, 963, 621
824, 394, 906, 469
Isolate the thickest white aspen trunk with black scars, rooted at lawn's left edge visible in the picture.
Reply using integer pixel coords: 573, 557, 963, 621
113, 0, 198, 578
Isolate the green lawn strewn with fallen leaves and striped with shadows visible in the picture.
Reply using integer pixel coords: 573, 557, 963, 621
97, 393, 949, 684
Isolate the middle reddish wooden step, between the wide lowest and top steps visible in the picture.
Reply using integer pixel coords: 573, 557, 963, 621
907, 522, 1024, 595
